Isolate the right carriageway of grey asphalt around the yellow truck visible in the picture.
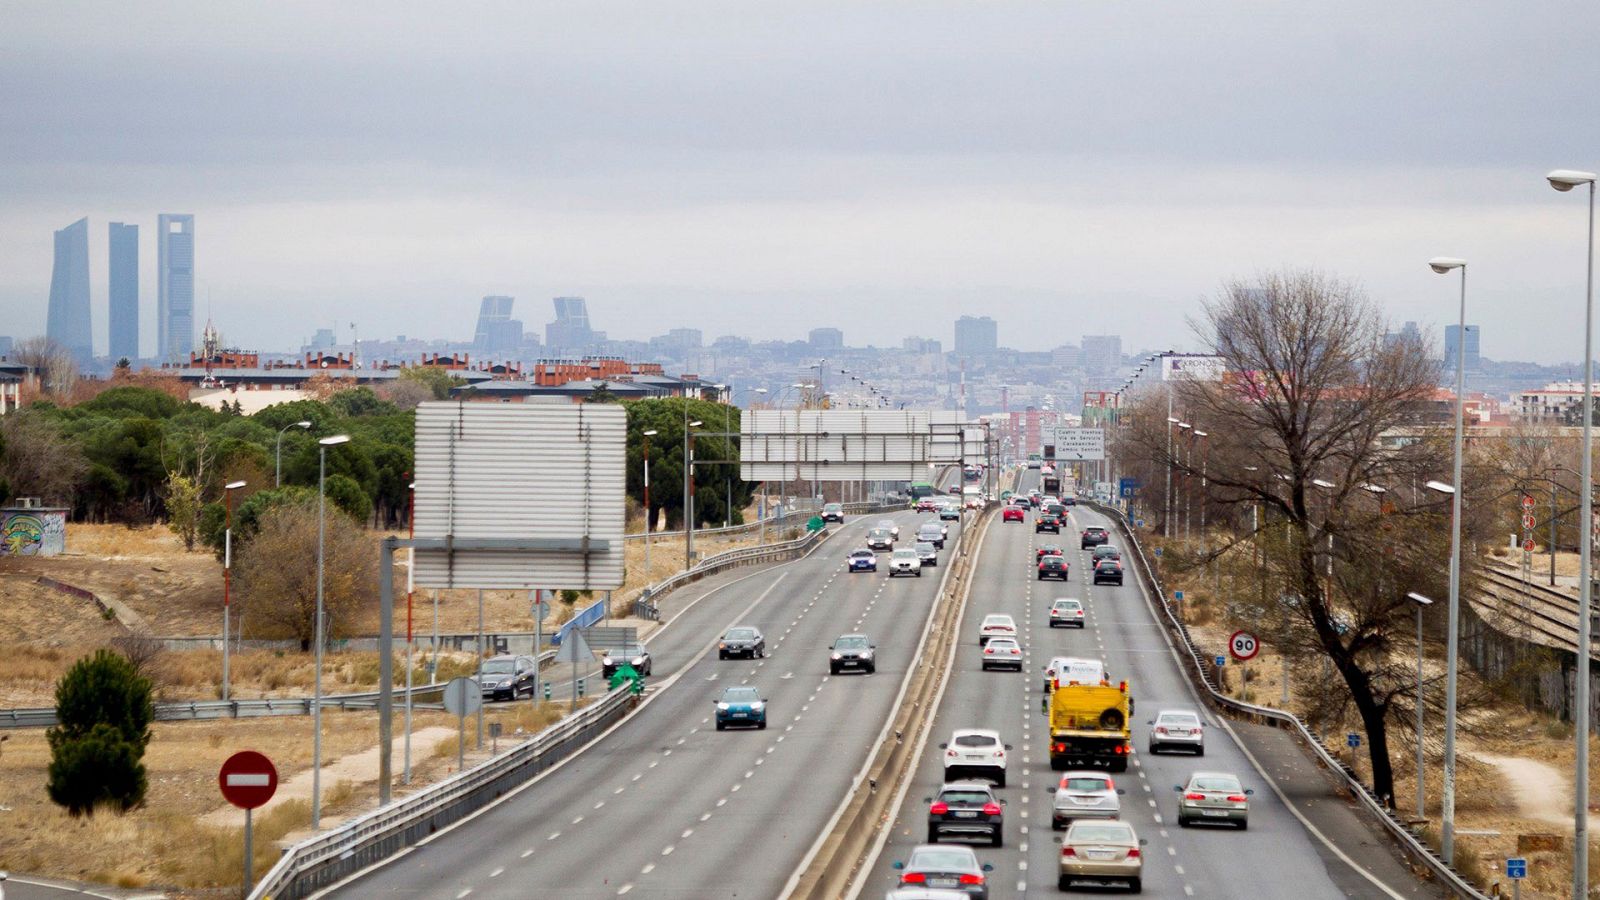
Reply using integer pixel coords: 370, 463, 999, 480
861, 471, 1411, 900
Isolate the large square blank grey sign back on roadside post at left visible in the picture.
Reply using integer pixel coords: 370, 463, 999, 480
416, 400, 627, 591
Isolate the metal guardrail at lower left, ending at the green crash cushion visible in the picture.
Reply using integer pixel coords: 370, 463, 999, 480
250, 690, 635, 900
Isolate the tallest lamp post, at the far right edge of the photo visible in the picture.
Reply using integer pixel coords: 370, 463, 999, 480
1544, 168, 1595, 897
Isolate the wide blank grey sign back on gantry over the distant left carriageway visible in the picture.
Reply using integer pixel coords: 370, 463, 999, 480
739, 410, 971, 482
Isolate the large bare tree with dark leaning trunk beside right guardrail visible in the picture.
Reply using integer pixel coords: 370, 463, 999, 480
1128, 271, 1448, 796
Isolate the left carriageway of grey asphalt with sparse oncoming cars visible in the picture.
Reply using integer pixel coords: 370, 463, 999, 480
330, 499, 958, 898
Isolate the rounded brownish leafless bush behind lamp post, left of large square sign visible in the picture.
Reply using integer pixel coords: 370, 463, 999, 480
235, 503, 378, 650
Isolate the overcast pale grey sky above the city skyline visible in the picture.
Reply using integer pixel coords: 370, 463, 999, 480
0, 0, 1600, 362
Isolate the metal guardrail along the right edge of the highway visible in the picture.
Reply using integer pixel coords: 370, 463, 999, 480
1085, 501, 1491, 900
